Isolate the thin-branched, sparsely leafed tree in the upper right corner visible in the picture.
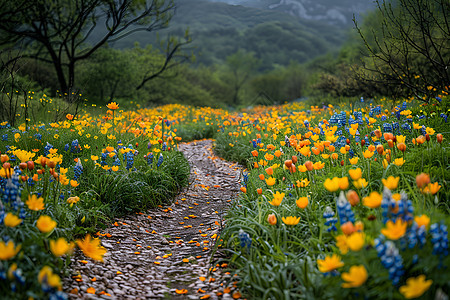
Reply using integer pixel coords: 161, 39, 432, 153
354, 0, 450, 102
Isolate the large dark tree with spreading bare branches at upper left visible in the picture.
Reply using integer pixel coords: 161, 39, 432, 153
0, 0, 180, 100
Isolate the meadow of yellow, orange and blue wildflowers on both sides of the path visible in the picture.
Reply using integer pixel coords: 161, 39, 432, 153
0, 91, 450, 299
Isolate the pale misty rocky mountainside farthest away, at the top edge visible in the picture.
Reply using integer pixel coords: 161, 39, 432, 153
206, 0, 375, 26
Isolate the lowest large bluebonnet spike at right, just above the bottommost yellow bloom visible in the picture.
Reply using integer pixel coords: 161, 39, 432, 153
374, 237, 405, 285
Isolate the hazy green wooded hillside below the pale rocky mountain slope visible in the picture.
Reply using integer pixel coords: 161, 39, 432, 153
106, 0, 370, 69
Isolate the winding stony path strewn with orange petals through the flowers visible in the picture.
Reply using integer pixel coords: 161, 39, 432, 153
64, 140, 240, 299
